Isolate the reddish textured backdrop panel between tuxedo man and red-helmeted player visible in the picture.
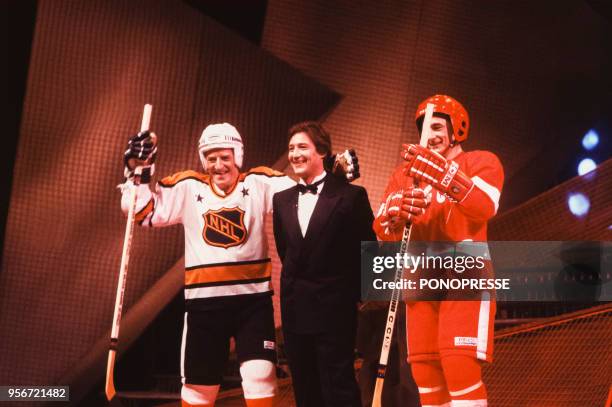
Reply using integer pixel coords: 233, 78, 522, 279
262, 0, 421, 207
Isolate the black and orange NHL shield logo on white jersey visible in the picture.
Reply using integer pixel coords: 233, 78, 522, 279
202, 207, 247, 249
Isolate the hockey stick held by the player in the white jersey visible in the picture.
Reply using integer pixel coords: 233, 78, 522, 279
104, 104, 153, 401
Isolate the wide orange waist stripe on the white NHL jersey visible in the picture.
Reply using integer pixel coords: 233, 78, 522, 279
185, 261, 272, 286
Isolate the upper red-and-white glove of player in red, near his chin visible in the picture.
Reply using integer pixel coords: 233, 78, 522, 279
401, 144, 474, 202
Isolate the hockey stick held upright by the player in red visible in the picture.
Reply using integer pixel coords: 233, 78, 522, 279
372, 103, 434, 407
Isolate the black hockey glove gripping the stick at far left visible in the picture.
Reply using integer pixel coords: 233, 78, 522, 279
123, 131, 157, 183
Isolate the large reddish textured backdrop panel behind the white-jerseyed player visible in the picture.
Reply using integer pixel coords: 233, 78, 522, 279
0, 0, 338, 384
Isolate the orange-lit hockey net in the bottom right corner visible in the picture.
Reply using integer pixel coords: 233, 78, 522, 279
484, 303, 612, 407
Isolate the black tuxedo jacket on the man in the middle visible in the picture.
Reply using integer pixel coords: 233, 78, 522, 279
273, 174, 376, 333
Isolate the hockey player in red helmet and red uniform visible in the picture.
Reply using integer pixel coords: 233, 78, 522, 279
374, 95, 504, 407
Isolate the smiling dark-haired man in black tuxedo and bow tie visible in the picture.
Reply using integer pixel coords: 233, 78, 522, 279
273, 122, 376, 407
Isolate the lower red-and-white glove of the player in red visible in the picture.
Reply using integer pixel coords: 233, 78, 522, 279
381, 187, 431, 226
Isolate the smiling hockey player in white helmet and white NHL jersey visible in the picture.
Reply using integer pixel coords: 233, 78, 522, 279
121, 123, 350, 407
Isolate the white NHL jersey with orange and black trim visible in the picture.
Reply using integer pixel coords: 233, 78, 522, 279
122, 167, 295, 310
